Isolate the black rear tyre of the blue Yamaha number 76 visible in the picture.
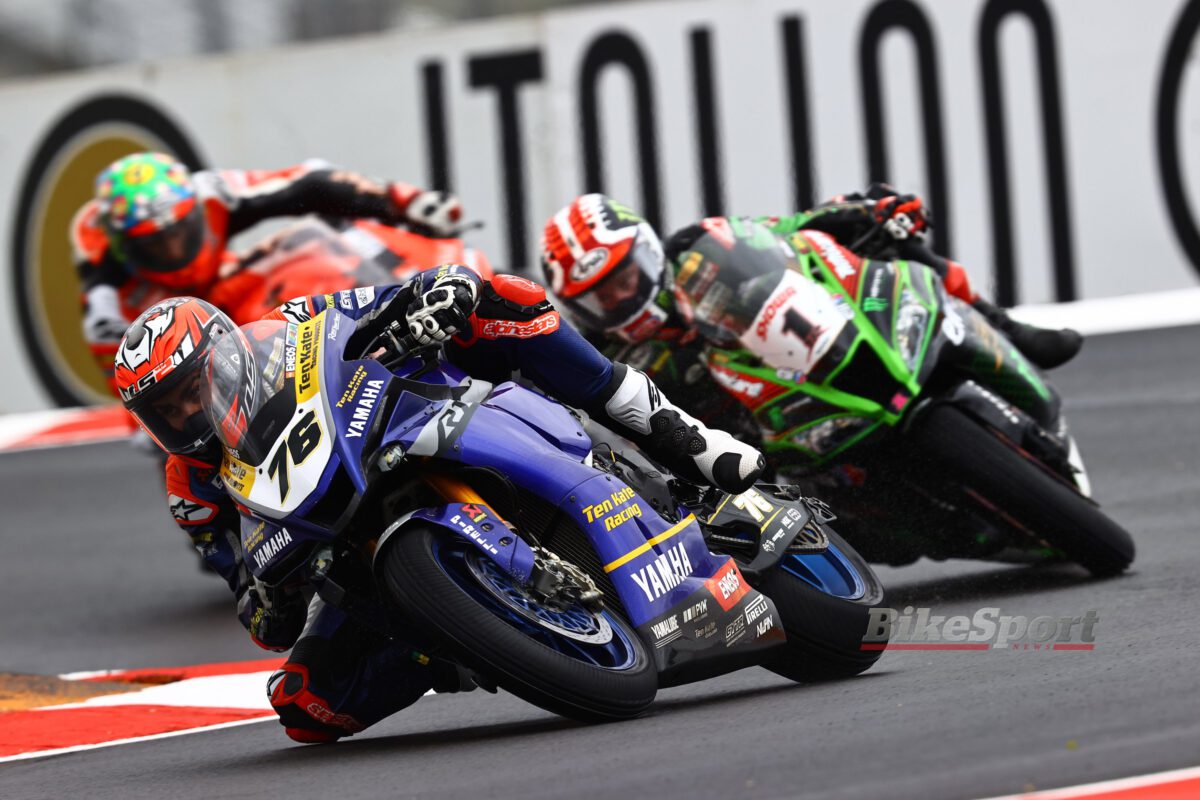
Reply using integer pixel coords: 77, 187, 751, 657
756, 525, 887, 684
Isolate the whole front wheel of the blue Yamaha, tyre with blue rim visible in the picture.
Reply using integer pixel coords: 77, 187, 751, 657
383, 524, 658, 722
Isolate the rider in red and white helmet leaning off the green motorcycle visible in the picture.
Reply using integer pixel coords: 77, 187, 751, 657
541, 184, 1082, 441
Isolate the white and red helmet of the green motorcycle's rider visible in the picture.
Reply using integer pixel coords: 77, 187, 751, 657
541, 194, 672, 342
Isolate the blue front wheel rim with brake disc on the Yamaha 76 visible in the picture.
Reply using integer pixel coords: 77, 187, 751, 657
433, 536, 638, 672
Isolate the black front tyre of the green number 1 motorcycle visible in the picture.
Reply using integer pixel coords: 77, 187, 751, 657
910, 405, 1135, 577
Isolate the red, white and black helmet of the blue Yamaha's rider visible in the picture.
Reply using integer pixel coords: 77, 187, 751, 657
114, 297, 236, 455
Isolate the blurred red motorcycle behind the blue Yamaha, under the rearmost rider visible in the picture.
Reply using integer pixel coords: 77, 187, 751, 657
208, 218, 494, 325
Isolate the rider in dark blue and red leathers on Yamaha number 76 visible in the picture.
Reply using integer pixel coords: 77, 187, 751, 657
116, 265, 763, 742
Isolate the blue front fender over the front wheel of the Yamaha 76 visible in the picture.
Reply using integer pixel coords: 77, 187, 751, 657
374, 503, 534, 584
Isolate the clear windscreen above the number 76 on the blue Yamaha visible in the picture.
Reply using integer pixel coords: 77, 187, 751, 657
203, 320, 298, 465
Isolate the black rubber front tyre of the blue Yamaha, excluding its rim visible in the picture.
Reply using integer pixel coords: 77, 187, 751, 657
383, 524, 658, 722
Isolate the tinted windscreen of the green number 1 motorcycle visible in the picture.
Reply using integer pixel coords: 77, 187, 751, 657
676, 221, 797, 347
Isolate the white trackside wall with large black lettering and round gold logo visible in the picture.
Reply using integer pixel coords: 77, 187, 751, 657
0, 0, 1200, 411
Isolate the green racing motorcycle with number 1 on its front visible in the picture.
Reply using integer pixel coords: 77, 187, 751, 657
676, 219, 1134, 576
